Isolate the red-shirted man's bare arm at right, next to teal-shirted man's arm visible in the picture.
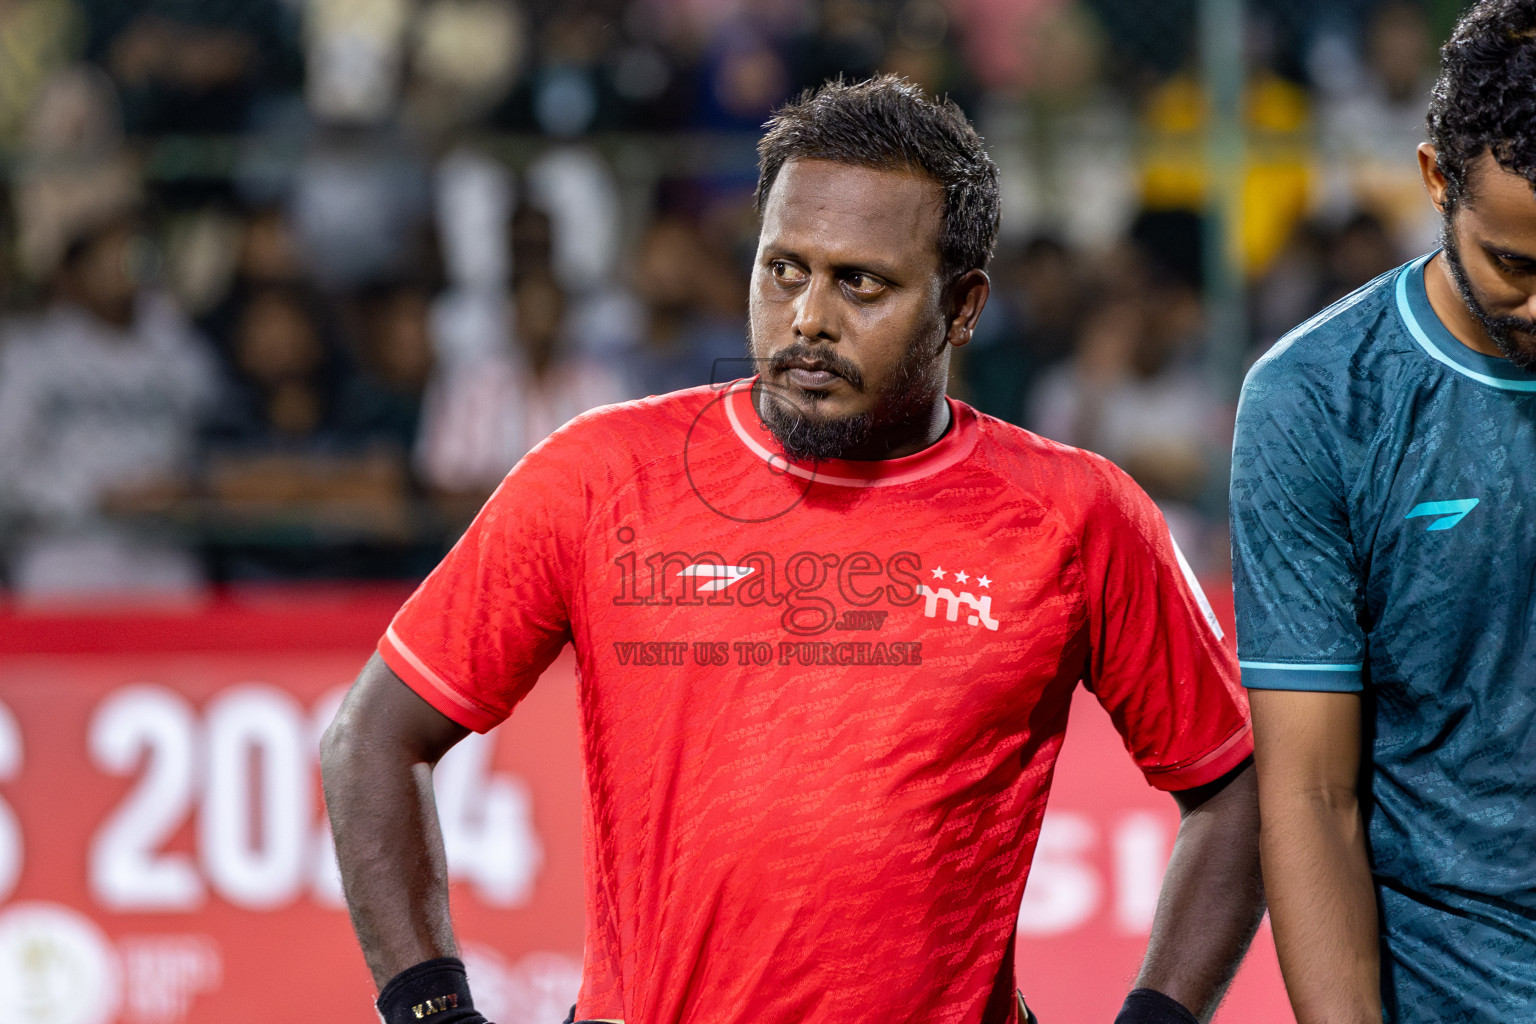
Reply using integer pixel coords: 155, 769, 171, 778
1137, 766, 1264, 1019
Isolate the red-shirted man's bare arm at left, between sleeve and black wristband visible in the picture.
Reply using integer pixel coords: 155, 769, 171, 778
319, 654, 468, 988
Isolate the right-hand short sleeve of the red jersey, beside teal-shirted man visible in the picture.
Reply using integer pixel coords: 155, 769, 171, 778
1081, 464, 1253, 791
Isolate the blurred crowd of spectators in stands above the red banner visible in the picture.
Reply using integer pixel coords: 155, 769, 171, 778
0, 0, 1461, 600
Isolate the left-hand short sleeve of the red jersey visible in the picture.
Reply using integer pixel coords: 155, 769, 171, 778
378, 427, 587, 732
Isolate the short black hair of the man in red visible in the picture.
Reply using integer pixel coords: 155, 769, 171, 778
757, 75, 997, 279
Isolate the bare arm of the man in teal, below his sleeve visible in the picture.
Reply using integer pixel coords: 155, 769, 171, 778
1249, 689, 1381, 1024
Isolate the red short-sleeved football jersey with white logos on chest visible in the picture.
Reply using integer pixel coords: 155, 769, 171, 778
379, 381, 1252, 1024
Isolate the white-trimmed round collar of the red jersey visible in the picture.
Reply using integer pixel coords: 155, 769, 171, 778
723, 378, 977, 487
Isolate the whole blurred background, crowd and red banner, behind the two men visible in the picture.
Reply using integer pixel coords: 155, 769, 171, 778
0, 0, 1462, 1024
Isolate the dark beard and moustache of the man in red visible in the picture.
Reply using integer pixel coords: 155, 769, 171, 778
759, 333, 934, 462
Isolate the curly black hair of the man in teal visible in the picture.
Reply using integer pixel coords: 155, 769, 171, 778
1428, 0, 1536, 209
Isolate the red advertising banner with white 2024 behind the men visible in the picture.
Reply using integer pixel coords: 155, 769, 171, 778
0, 590, 1292, 1024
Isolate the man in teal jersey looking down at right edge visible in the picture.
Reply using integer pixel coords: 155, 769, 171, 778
1232, 0, 1536, 1024
